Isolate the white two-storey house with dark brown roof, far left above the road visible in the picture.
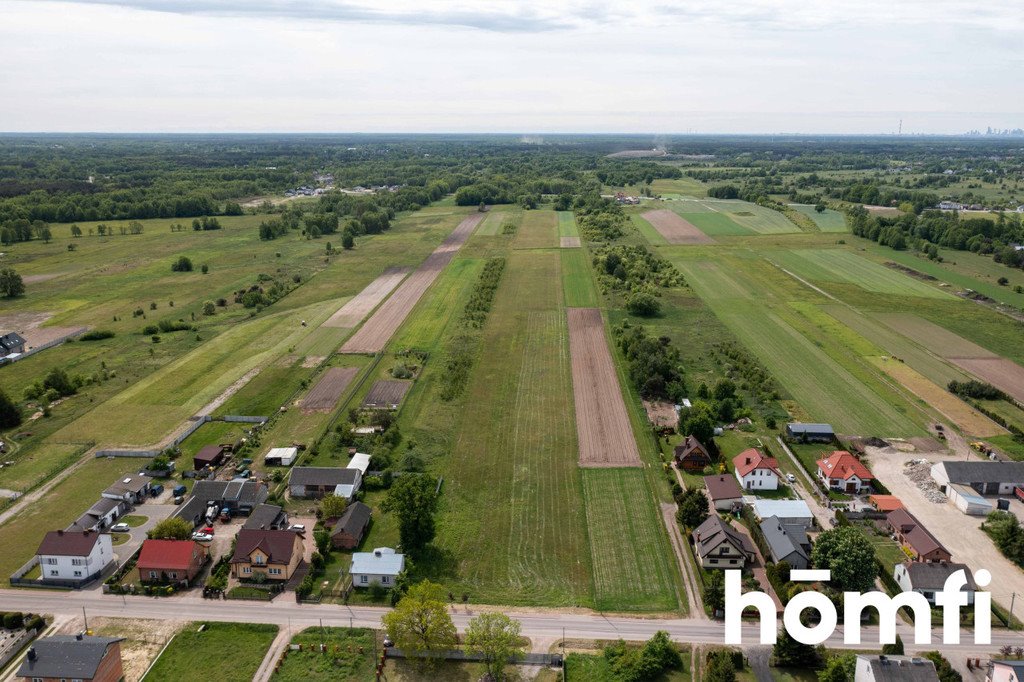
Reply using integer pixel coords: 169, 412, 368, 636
36, 530, 114, 586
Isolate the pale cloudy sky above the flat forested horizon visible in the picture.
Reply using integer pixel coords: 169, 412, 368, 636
0, 0, 1024, 134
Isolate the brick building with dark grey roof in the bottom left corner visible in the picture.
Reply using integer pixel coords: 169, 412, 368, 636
17, 635, 125, 682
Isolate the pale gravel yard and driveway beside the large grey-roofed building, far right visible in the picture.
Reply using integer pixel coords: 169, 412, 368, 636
868, 447, 1024, 617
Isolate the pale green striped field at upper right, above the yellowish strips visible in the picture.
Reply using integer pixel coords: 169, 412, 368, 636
768, 249, 949, 298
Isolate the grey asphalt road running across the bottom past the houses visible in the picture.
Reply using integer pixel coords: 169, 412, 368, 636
0, 590, 1024, 655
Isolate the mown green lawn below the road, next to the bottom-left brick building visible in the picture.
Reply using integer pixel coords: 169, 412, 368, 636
142, 623, 278, 682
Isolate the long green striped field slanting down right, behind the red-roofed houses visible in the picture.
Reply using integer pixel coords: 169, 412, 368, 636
676, 261, 921, 436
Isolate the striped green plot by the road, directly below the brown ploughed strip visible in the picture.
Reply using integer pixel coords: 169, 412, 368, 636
582, 469, 681, 611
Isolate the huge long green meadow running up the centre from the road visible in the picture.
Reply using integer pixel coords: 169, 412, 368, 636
437, 252, 591, 606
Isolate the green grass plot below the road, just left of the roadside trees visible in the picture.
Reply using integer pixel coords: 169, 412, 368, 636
270, 628, 376, 682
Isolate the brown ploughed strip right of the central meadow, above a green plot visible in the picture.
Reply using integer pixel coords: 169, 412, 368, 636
566, 308, 642, 467
